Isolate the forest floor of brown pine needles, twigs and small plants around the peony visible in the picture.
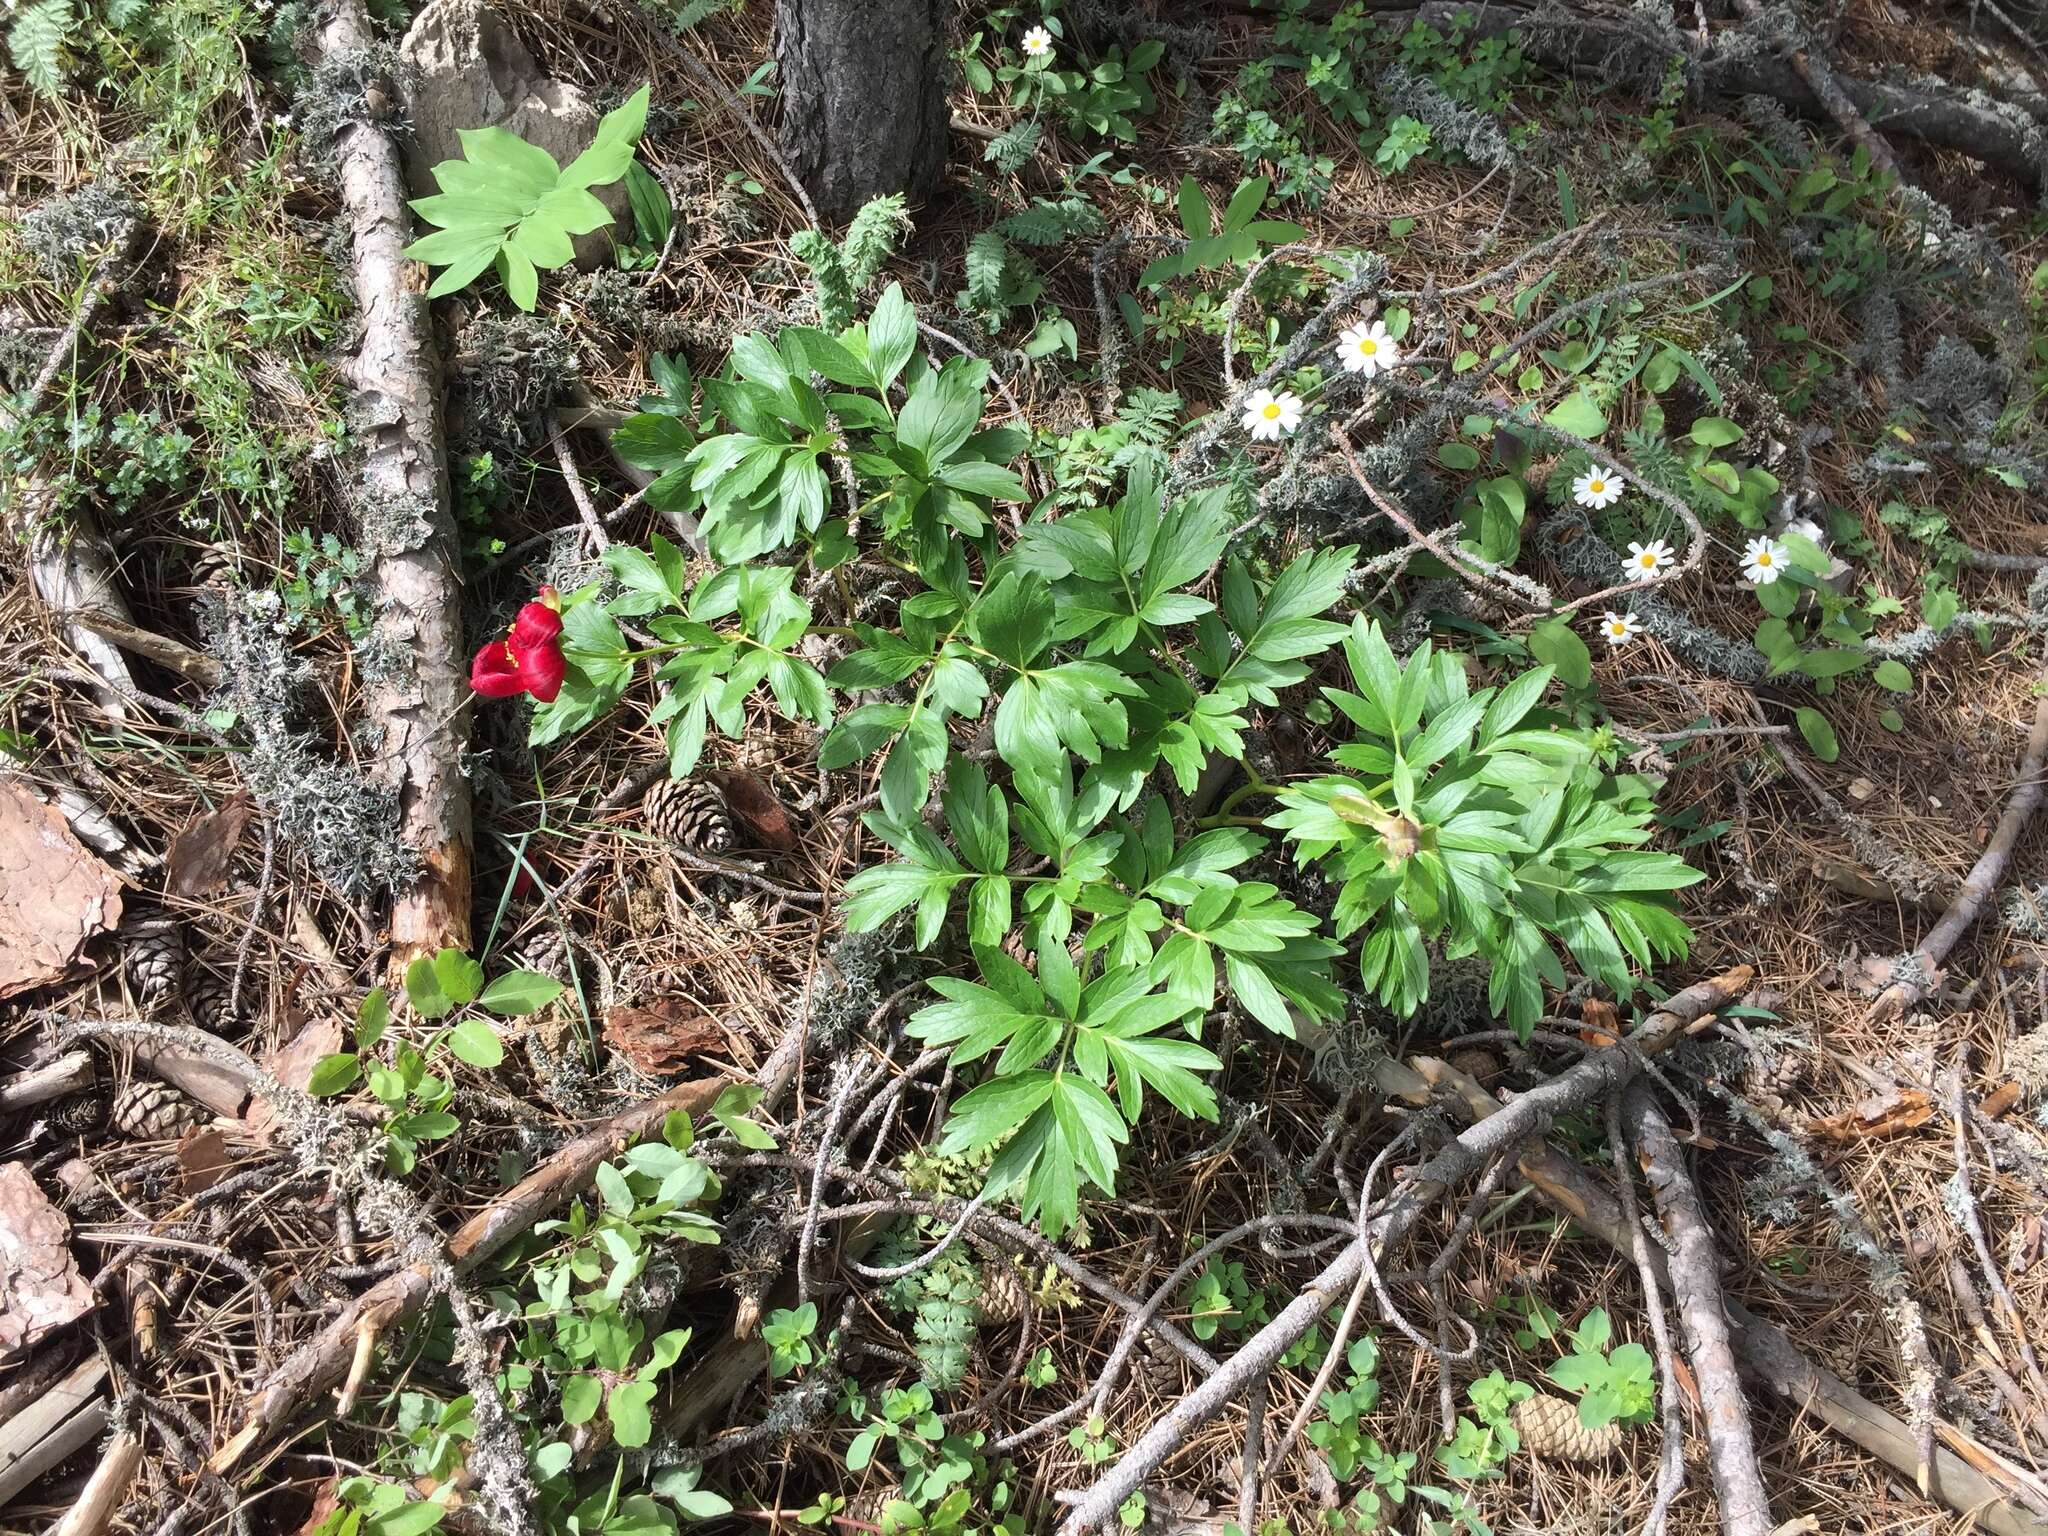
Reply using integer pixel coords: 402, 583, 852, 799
0, 0, 2048, 1536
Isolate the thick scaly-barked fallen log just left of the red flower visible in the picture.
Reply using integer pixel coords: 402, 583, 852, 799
319, 0, 471, 967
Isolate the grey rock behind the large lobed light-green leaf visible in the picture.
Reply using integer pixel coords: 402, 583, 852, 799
399, 0, 633, 270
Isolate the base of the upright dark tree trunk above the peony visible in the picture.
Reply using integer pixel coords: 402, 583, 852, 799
776, 0, 948, 225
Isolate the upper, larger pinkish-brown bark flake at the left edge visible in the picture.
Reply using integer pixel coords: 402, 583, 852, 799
0, 782, 121, 997
